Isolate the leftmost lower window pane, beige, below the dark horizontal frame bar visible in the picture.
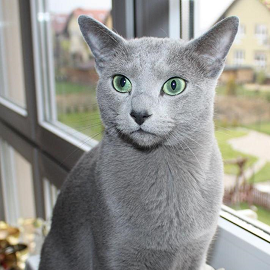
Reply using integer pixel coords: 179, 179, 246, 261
0, 140, 36, 226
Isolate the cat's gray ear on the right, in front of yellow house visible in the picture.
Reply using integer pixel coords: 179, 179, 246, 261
188, 16, 239, 76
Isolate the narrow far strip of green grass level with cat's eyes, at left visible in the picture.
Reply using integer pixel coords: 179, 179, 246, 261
55, 82, 96, 95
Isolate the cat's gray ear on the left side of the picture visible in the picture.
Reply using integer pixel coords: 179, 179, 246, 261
78, 15, 125, 72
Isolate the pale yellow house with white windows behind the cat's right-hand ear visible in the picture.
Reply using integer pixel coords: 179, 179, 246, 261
218, 0, 270, 82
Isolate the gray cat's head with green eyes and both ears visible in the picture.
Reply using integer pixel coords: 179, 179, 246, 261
79, 16, 239, 147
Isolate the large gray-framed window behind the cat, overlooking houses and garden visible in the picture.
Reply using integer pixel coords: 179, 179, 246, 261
0, 0, 270, 270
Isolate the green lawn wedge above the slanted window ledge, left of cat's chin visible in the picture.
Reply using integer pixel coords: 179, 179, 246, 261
58, 111, 104, 141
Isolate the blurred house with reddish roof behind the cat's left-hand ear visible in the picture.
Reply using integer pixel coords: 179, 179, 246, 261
51, 8, 112, 84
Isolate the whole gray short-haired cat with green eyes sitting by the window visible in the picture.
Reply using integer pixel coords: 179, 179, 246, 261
39, 16, 239, 270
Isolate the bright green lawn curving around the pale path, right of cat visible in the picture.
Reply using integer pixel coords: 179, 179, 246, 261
216, 129, 257, 175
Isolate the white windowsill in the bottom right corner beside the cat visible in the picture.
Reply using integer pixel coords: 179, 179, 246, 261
209, 213, 270, 270
